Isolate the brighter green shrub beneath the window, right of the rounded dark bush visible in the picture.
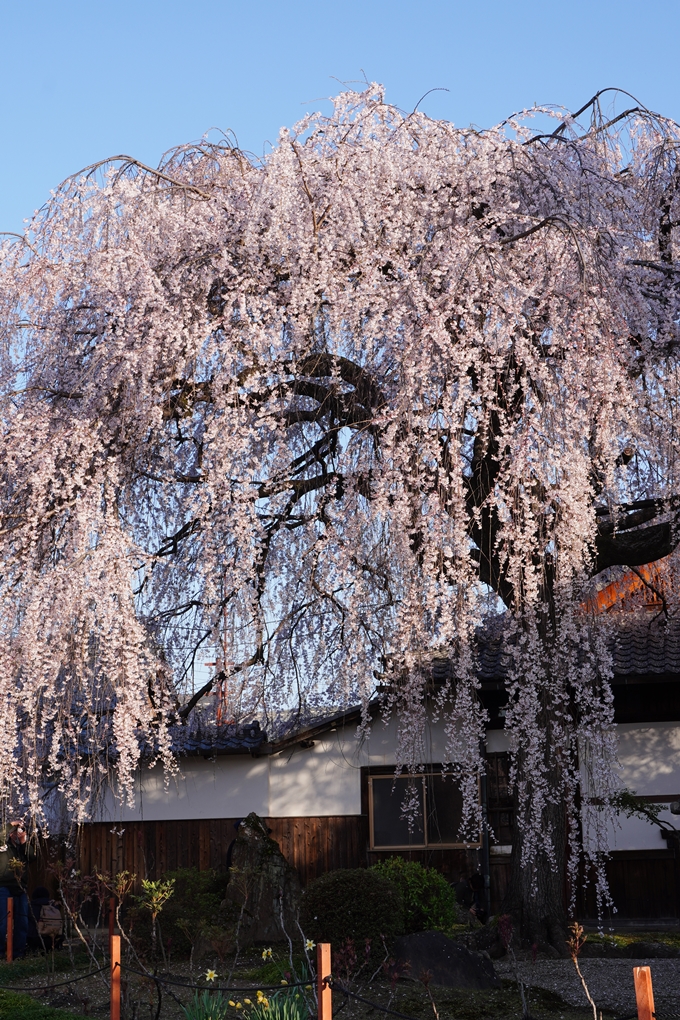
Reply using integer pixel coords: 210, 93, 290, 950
371, 857, 458, 932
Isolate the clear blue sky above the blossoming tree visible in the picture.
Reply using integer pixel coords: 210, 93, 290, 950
0, 0, 680, 231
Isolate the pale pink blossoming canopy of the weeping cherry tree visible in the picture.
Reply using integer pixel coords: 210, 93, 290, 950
0, 87, 680, 893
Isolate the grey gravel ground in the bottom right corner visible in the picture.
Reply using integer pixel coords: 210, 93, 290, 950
494, 960, 680, 1020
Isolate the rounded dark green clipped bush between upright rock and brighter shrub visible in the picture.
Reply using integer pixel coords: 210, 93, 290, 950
301, 868, 404, 949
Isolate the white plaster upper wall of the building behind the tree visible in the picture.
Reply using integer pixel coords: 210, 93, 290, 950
96, 720, 680, 850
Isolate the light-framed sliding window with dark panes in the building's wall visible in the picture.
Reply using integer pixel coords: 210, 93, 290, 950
368, 771, 480, 850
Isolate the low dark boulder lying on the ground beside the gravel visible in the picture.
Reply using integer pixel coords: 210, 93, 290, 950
394, 931, 501, 990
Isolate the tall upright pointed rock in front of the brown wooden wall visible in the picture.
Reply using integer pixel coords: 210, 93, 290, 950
224, 812, 300, 949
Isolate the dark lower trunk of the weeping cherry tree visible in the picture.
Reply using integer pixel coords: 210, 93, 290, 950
501, 779, 569, 957
